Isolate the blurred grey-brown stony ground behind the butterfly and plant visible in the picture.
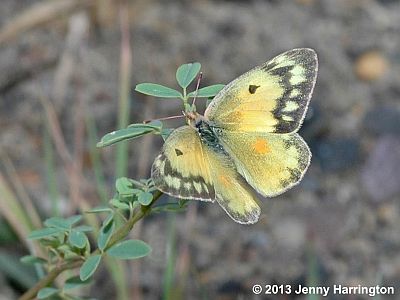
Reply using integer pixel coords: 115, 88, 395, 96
0, 0, 400, 299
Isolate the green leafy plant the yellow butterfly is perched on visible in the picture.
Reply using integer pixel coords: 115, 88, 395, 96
20, 63, 223, 299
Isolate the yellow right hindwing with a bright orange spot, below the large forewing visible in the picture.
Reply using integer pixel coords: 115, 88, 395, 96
218, 130, 311, 197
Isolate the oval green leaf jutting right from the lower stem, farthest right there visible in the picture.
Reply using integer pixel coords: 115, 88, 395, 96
107, 240, 151, 259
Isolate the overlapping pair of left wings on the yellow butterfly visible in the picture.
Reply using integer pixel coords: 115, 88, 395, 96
151, 126, 260, 224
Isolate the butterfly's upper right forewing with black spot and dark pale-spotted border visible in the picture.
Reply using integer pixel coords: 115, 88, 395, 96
205, 48, 318, 133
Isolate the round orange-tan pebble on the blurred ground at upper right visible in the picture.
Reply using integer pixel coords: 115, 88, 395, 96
354, 51, 389, 81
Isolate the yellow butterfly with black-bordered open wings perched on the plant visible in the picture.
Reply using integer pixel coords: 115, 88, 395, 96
151, 48, 318, 224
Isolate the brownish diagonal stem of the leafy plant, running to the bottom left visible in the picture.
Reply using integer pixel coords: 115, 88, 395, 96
19, 191, 163, 300
